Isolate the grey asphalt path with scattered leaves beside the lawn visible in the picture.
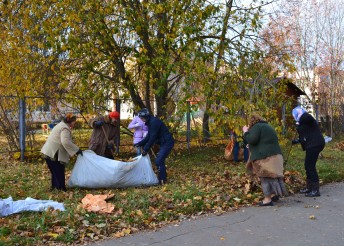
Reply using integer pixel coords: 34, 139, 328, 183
92, 183, 344, 246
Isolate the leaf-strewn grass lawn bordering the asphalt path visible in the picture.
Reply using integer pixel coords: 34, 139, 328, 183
0, 137, 344, 245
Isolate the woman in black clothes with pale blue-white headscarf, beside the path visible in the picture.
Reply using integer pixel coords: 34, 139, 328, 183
292, 106, 325, 197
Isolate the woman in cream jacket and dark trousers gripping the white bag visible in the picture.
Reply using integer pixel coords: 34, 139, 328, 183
41, 114, 82, 191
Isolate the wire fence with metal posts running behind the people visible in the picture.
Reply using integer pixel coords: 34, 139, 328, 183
0, 96, 344, 160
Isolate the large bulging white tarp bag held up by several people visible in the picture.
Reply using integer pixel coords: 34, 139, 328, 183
68, 150, 158, 188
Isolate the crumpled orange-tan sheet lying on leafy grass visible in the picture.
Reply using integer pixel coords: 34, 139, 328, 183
81, 194, 115, 213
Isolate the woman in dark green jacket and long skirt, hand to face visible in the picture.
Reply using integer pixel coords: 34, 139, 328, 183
243, 113, 287, 206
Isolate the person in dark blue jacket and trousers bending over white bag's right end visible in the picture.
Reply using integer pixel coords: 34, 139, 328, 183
134, 108, 174, 185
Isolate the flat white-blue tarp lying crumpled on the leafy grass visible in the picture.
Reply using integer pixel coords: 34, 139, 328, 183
0, 197, 65, 217
